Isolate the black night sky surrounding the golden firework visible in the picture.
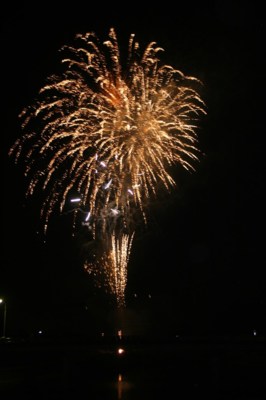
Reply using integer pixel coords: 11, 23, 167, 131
0, 1, 266, 333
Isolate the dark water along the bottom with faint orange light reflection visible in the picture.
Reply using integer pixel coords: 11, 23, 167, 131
0, 341, 266, 400
